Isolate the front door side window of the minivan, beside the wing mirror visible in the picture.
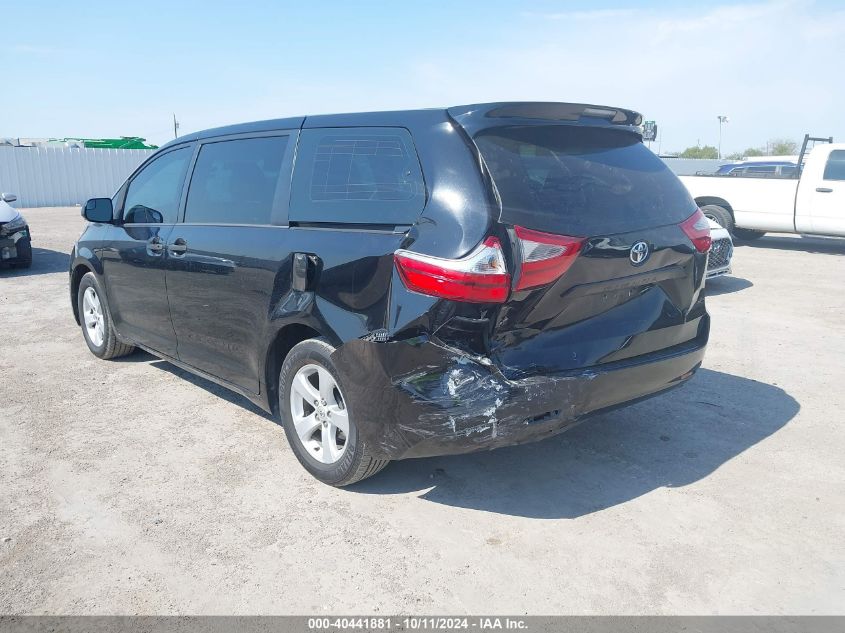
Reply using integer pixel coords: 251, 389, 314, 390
123, 147, 193, 224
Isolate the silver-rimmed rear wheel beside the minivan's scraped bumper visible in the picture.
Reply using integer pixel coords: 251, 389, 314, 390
278, 338, 390, 486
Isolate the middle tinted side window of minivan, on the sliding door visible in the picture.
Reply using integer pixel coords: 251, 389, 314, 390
185, 136, 288, 224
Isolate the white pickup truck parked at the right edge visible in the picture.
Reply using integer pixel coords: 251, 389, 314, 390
680, 135, 845, 240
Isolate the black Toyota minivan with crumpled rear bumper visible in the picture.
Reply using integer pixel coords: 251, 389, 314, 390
70, 103, 710, 486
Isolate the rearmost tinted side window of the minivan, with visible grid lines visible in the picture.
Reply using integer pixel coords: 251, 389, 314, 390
290, 127, 425, 224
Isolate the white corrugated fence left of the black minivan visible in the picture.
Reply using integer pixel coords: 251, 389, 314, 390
0, 146, 153, 207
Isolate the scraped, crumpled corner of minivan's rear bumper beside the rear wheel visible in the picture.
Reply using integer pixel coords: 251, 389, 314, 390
333, 335, 589, 458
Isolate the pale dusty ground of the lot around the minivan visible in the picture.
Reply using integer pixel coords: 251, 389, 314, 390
0, 208, 845, 614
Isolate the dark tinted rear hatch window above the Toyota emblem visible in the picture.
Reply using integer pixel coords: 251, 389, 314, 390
475, 125, 695, 237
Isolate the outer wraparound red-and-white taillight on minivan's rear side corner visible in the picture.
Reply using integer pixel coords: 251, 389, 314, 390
393, 237, 511, 303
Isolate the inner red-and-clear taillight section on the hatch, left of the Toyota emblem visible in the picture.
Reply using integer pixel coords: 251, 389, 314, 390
514, 226, 584, 290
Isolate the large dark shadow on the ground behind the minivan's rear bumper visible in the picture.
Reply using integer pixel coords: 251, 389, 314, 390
350, 369, 800, 519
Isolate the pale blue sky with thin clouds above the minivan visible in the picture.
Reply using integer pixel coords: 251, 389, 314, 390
0, 0, 845, 153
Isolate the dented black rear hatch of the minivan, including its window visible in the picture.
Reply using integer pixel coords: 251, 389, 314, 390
450, 104, 709, 377
